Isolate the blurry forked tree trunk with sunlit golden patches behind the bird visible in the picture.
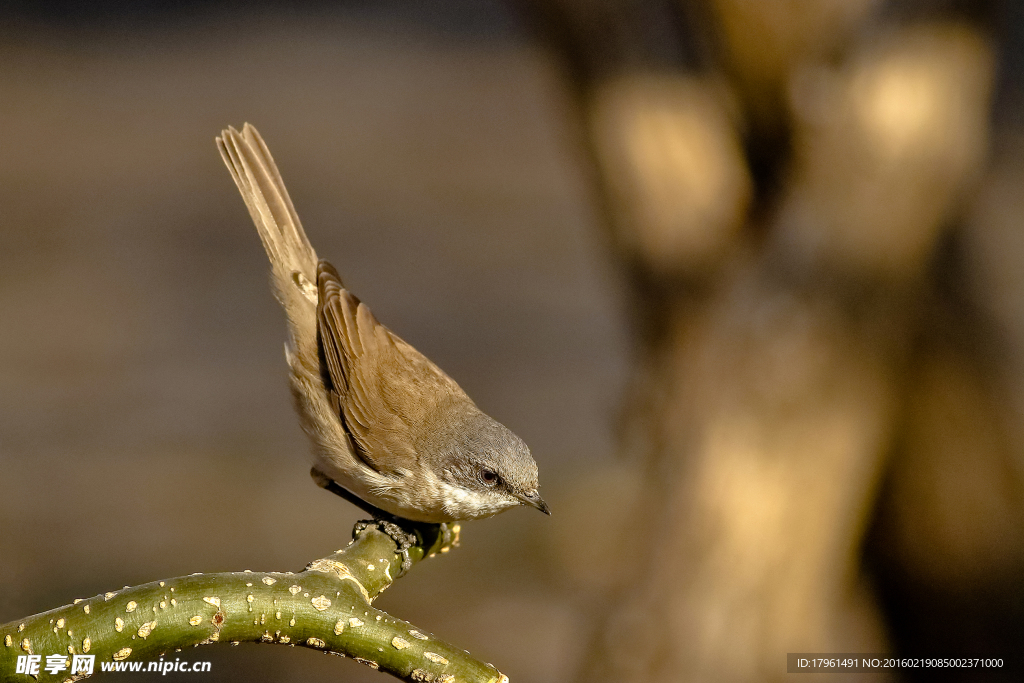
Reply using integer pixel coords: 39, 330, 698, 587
526, 0, 1007, 682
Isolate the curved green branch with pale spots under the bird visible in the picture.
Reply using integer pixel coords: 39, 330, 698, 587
0, 523, 508, 683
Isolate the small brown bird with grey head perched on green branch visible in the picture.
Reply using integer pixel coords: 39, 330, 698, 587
217, 124, 550, 523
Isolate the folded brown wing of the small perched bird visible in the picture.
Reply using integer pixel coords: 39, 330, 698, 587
316, 260, 468, 474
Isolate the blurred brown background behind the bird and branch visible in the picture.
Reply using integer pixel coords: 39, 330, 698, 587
0, 0, 1024, 683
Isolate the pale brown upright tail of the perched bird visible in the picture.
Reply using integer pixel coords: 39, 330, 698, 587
217, 123, 316, 366
